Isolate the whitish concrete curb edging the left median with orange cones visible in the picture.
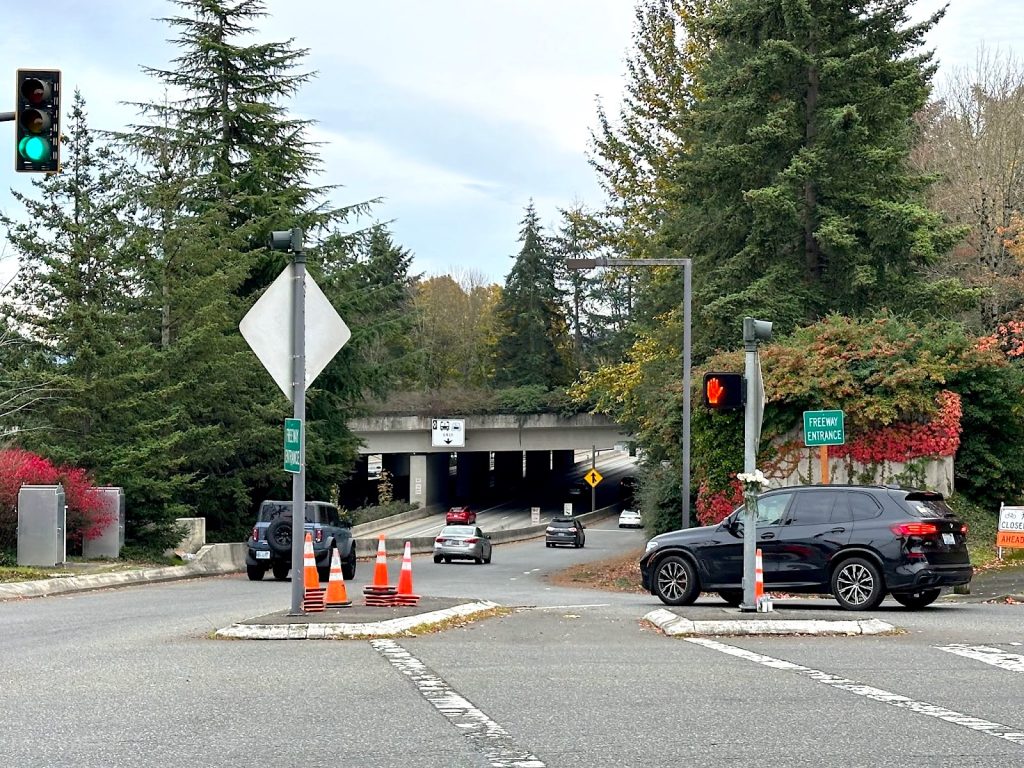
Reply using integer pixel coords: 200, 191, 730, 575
215, 600, 501, 640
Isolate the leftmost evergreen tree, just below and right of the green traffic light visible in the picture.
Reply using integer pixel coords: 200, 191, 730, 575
0, 91, 189, 548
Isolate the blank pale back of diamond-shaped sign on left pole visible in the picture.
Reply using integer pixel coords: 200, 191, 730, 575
239, 264, 352, 400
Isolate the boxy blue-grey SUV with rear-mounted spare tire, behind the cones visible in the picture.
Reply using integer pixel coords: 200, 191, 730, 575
246, 501, 355, 582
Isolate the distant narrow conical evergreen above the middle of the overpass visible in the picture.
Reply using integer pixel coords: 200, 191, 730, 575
495, 202, 574, 389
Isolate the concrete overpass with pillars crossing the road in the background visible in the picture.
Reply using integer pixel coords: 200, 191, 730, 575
342, 414, 630, 506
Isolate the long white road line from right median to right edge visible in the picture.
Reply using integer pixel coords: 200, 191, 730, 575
686, 637, 1024, 746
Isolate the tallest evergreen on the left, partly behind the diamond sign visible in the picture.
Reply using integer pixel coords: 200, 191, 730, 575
113, 0, 376, 539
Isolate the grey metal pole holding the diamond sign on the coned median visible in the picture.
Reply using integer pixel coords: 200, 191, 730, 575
290, 228, 307, 615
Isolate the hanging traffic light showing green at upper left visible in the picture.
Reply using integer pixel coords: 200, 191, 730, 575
14, 70, 60, 173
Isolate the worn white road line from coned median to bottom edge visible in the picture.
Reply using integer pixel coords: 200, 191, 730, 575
370, 640, 545, 768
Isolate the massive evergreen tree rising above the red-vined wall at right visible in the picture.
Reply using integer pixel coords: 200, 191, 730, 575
667, 0, 972, 352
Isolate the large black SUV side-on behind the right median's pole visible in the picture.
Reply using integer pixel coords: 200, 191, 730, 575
640, 485, 973, 610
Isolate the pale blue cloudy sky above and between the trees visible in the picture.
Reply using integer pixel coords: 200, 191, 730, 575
0, 0, 1024, 285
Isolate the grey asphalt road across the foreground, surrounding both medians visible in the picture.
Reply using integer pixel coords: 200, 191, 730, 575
0, 518, 1024, 768
